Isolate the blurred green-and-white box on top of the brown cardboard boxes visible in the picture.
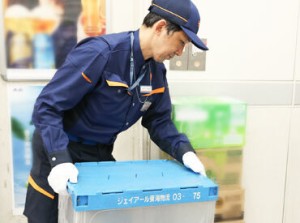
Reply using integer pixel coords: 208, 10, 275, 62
172, 97, 246, 149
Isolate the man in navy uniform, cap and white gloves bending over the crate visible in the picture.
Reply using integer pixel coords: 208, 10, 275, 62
24, 0, 207, 223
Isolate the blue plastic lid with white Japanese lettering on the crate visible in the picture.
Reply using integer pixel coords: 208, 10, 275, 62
68, 160, 218, 211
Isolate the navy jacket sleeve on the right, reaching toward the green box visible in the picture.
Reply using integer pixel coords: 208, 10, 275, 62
142, 81, 195, 163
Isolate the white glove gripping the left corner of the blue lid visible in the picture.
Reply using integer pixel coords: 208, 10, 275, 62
48, 163, 78, 194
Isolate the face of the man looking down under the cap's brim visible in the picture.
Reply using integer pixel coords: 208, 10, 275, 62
153, 27, 190, 62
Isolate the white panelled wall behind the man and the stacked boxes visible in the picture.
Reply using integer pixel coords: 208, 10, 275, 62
0, 0, 300, 223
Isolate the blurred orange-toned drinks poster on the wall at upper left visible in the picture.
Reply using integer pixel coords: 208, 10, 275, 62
1, 0, 107, 80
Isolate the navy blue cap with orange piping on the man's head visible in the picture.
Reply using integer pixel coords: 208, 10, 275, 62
149, 0, 208, 50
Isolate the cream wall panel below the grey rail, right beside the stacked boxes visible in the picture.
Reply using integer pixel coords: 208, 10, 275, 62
243, 107, 295, 223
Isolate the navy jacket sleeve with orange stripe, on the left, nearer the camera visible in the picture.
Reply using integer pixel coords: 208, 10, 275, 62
32, 40, 107, 166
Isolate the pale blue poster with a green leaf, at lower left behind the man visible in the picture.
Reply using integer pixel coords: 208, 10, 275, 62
8, 85, 43, 214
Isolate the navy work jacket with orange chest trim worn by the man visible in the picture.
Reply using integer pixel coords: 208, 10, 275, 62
32, 30, 193, 166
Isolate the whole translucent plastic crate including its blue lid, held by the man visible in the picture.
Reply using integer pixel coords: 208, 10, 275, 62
59, 160, 218, 223
